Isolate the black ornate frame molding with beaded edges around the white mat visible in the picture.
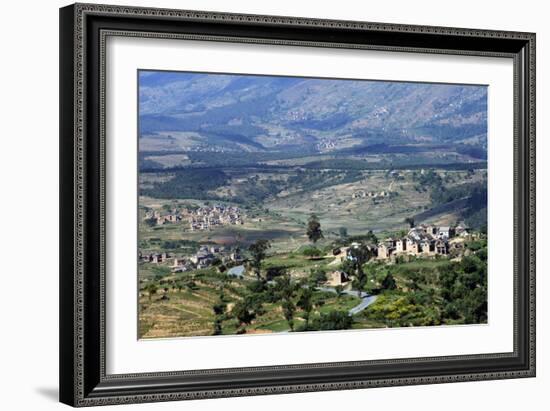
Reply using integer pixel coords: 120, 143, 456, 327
60, 4, 535, 406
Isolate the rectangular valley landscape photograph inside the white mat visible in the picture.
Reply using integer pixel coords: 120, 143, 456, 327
137, 70, 490, 339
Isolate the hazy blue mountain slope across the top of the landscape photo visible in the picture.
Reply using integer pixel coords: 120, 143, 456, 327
139, 72, 487, 152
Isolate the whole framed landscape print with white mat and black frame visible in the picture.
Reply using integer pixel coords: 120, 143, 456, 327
60, 4, 535, 406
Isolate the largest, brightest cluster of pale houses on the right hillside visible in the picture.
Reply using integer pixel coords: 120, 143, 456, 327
377, 225, 470, 260
